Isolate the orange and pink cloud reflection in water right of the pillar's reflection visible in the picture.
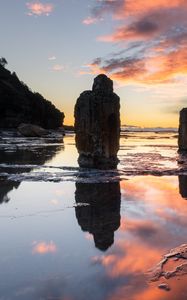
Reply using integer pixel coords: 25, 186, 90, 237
88, 176, 187, 300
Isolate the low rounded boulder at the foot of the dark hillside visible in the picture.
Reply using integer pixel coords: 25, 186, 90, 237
18, 124, 48, 137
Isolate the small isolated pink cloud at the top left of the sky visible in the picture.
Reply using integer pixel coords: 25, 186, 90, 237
26, 1, 54, 16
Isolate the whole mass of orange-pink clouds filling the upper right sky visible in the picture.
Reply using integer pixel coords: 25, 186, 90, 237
85, 0, 187, 84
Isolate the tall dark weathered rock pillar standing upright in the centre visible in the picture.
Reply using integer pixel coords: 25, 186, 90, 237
75, 74, 120, 169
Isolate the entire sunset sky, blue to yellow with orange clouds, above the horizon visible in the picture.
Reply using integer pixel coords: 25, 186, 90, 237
0, 0, 187, 127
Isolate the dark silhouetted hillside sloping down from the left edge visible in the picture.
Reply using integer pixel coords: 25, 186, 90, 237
0, 64, 64, 129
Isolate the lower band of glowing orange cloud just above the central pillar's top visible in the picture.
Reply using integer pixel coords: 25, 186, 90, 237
88, 43, 187, 84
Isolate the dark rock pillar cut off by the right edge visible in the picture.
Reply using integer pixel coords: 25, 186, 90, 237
178, 108, 187, 150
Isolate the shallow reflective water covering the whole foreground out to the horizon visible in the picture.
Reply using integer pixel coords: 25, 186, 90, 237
0, 133, 187, 300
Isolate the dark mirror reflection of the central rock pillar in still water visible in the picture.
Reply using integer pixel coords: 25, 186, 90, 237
75, 182, 121, 251
